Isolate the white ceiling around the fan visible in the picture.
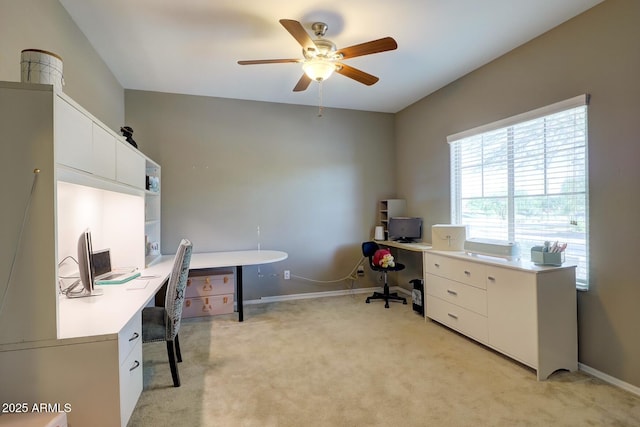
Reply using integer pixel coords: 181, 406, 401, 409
60, 0, 602, 113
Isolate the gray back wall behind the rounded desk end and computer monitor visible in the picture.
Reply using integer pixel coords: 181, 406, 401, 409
125, 90, 395, 299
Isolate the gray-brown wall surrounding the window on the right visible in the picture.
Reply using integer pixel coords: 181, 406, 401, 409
396, 0, 640, 386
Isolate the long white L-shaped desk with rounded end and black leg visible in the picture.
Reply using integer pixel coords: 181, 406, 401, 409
0, 250, 288, 427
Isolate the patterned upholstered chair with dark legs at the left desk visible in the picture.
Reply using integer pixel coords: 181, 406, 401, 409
142, 239, 193, 387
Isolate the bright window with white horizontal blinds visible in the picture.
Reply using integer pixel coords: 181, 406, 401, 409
447, 95, 589, 289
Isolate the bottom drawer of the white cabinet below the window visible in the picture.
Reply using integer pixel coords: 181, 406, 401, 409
427, 296, 489, 344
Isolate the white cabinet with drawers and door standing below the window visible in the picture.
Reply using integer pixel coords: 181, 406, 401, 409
424, 251, 578, 380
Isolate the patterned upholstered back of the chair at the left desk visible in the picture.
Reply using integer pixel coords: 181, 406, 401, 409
165, 239, 193, 341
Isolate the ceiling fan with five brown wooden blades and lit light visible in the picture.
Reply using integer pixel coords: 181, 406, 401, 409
238, 19, 398, 92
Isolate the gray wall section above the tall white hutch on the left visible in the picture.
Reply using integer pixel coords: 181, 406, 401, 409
0, 0, 124, 133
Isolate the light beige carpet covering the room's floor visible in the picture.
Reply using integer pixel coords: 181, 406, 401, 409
129, 295, 640, 427
